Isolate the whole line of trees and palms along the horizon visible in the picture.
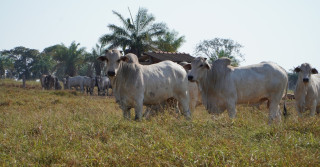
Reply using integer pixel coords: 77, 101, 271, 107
0, 8, 248, 79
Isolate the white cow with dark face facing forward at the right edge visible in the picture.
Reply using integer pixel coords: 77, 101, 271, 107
294, 63, 320, 116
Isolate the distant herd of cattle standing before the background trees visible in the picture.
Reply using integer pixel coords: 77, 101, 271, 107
40, 75, 111, 96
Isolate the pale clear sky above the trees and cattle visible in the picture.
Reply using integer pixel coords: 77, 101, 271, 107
0, 0, 320, 70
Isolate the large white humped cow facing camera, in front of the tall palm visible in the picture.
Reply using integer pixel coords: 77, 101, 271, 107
98, 50, 191, 120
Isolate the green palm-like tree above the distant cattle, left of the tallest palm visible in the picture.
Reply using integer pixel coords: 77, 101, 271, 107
49, 41, 86, 78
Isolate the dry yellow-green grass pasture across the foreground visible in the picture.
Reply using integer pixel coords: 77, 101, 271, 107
0, 80, 320, 166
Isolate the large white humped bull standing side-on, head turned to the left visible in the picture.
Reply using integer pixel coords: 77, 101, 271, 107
186, 57, 288, 123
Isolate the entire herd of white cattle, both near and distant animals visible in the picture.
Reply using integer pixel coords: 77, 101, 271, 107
41, 50, 320, 123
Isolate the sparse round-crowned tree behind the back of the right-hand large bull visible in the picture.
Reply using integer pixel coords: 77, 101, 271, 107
195, 38, 244, 66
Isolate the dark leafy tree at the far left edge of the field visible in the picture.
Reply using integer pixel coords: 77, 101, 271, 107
2, 46, 40, 79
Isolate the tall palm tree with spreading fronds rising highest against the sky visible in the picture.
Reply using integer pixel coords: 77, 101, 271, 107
100, 8, 167, 57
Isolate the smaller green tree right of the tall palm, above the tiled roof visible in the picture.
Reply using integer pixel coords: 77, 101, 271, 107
155, 31, 185, 52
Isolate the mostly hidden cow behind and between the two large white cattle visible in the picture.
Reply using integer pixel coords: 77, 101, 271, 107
179, 62, 202, 112
